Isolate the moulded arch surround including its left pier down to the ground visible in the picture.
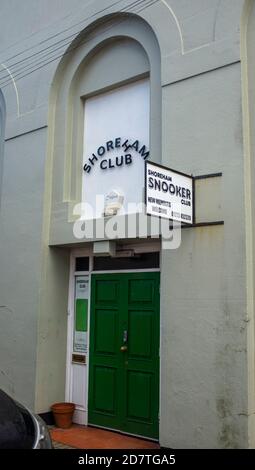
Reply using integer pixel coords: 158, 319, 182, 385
35, 11, 161, 412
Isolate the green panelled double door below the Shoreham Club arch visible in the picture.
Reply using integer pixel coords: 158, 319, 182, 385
88, 272, 159, 439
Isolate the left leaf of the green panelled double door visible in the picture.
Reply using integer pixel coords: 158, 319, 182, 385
89, 276, 120, 428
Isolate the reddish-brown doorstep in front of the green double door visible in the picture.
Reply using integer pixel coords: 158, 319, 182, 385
50, 424, 160, 449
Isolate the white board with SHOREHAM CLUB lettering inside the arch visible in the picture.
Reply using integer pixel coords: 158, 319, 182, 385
82, 78, 150, 219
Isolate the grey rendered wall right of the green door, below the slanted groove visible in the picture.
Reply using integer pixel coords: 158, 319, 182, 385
161, 64, 247, 448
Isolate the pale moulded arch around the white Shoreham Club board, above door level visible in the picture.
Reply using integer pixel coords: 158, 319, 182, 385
47, 14, 161, 245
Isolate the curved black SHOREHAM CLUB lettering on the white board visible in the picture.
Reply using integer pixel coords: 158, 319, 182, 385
83, 137, 150, 173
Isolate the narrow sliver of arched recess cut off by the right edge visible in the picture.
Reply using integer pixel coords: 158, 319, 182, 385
241, 0, 255, 448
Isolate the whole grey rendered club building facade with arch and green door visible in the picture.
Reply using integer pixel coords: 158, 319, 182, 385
0, 0, 255, 448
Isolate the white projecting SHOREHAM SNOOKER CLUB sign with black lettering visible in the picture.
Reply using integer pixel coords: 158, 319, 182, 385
145, 162, 194, 224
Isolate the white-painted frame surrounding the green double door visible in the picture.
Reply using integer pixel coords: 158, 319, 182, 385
65, 243, 161, 430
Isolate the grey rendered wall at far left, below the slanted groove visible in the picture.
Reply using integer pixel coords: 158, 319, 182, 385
0, 129, 46, 408
